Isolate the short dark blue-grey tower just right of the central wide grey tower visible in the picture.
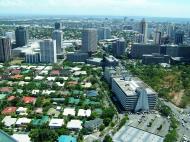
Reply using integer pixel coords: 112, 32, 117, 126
112, 39, 125, 57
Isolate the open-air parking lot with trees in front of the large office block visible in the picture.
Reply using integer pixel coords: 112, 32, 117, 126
129, 113, 170, 137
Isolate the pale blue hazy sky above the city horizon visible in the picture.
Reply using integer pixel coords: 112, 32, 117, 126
0, 0, 190, 18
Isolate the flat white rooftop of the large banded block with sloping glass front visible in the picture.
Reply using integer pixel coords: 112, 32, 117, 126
113, 77, 157, 96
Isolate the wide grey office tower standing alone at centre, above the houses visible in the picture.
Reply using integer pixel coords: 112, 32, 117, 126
82, 29, 97, 53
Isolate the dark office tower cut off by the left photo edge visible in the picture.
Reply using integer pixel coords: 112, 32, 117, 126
0, 37, 11, 62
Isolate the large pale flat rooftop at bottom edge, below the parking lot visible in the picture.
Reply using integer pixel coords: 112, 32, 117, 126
113, 125, 164, 142
